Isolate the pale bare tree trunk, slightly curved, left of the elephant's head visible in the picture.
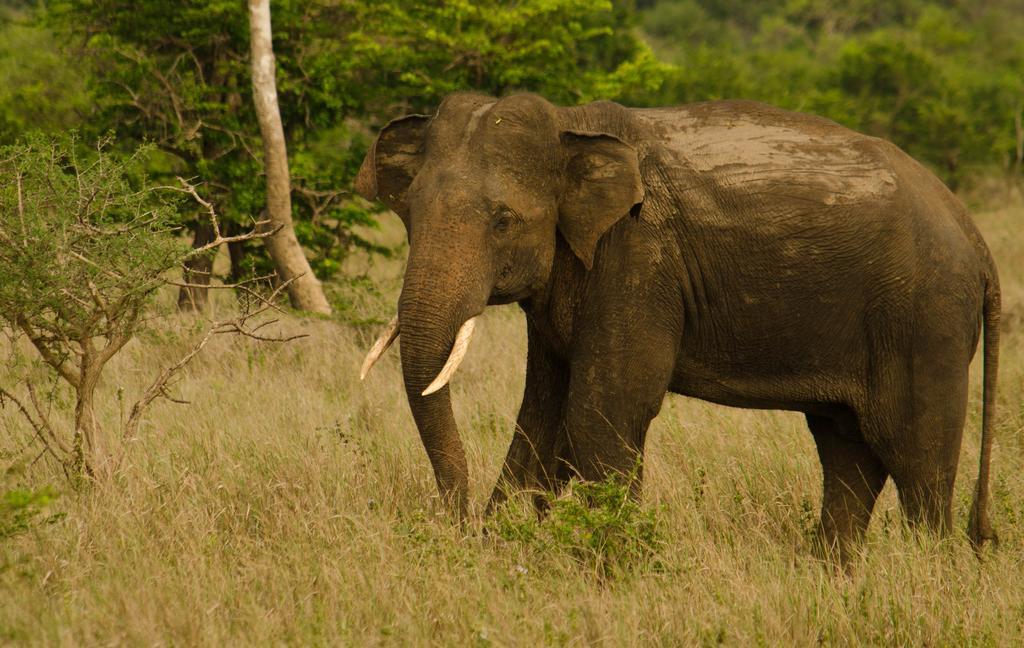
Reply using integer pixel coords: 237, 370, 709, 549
249, 0, 331, 314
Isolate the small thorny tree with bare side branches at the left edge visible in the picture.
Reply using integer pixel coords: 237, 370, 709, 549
0, 136, 292, 478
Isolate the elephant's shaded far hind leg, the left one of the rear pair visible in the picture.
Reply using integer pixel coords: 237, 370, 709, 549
807, 415, 889, 563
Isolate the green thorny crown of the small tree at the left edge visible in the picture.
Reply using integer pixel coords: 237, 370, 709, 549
0, 136, 184, 341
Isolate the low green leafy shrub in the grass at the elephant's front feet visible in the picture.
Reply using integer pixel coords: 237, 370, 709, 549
488, 477, 665, 578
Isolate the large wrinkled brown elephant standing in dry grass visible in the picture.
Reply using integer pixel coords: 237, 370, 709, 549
356, 93, 999, 553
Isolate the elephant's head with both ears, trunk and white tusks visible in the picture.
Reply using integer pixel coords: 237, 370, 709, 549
355, 93, 643, 514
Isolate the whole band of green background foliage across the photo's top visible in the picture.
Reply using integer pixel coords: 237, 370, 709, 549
0, 0, 1024, 288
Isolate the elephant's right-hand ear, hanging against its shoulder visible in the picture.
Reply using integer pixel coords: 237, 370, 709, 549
558, 131, 643, 270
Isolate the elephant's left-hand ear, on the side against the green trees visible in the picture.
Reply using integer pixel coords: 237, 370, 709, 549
355, 115, 430, 218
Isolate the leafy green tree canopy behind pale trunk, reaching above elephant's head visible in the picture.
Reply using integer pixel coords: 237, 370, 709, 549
6, 0, 668, 288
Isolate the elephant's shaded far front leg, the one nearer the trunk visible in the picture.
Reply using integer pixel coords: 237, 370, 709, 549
487, 325, 568, 513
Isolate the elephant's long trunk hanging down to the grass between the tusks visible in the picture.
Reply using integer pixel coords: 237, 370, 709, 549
398, 251, 489, 516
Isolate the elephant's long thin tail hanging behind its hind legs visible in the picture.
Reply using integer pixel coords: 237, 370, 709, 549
967, 267, 1000, 552
